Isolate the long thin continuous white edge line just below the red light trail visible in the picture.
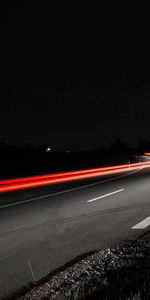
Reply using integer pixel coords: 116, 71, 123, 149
0, 167, 144, 209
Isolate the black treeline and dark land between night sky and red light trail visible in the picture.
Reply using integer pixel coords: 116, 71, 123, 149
0, 139, 150, 179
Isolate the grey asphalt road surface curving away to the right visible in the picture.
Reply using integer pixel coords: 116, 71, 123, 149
0, 164, 150, 299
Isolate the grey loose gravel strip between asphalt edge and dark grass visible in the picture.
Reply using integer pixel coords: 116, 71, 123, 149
5, 241, 150, 300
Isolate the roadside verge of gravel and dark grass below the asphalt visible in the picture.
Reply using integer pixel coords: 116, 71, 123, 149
5, 231, 150, 300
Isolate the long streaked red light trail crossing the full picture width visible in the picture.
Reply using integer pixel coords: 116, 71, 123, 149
0, 162, 150, 193
